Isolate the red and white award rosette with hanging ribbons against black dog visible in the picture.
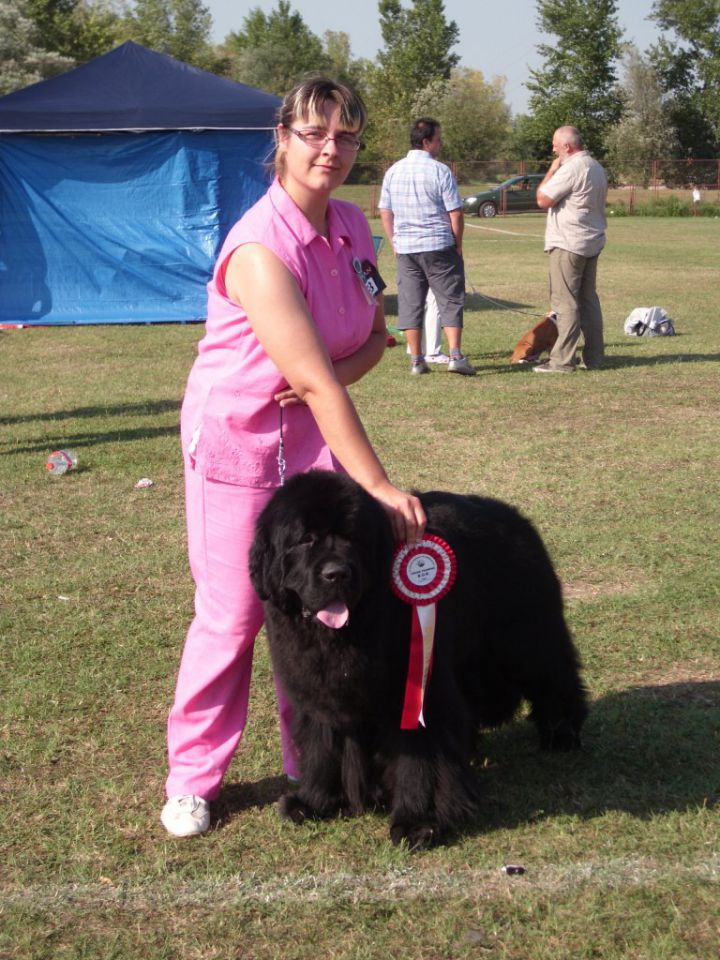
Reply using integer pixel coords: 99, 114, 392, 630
391, 533, 457, 730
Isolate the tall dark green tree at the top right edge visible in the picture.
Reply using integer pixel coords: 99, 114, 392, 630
650, 0, 720, 158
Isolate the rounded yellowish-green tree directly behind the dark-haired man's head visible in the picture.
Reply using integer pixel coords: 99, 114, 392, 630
413, 67, 511, 160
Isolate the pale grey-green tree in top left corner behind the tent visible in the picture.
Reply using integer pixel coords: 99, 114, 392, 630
0, 0, 74, 95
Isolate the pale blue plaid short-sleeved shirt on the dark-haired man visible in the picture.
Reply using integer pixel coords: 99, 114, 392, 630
380, 150, 462, 253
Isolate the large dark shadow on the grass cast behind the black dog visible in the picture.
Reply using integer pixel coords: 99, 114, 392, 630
466, 681, 720, 834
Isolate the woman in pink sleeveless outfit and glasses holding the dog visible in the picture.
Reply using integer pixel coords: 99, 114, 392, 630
161, 78, 425, 836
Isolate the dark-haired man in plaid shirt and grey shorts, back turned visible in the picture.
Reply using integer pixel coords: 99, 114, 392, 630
380, 118, 475, 376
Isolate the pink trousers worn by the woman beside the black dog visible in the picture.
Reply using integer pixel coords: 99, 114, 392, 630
166, 464, 298, 800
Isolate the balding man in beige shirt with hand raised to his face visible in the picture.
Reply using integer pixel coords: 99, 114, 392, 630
533, 127, 607, 373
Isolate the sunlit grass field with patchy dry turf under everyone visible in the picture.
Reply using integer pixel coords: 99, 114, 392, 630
0, 216, 720, 960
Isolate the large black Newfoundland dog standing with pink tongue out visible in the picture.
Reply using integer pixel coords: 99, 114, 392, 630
250, 471, 587, 848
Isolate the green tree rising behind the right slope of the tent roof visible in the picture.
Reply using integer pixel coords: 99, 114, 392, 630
125, 0, 216, 70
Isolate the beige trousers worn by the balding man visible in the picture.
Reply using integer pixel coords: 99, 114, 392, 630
549, 247, 605, 370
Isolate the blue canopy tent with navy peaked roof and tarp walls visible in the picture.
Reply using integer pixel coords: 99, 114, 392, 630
0, 42, 280, 325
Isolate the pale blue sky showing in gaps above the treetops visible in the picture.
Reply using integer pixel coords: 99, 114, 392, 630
205, 0, 658, 113
